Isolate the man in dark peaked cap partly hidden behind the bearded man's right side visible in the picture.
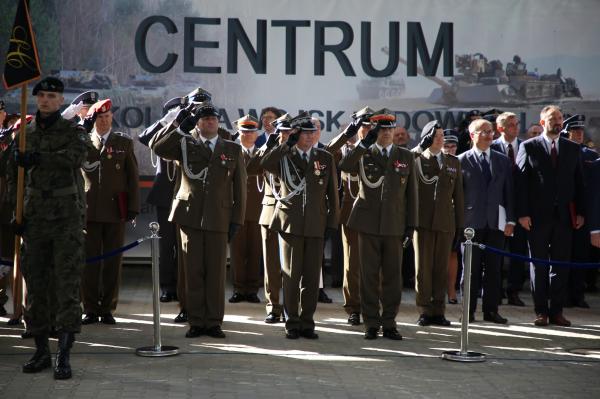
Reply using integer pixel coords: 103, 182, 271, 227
562, 114, 598, 308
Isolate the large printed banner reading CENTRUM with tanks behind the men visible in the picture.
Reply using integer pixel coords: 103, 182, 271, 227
0, 0, 600, 260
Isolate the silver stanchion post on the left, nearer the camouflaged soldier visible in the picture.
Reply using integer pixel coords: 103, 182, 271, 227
135, 222, 179, 357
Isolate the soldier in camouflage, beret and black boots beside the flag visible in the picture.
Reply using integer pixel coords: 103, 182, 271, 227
5, 77, 91, 379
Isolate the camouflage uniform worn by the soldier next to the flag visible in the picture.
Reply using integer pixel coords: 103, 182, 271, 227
9, 112, 91, 336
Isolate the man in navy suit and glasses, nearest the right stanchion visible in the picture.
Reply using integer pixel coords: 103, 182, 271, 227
458, 119, 515, 324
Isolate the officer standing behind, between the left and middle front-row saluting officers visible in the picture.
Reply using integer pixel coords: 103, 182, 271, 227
229, 115, 262, 303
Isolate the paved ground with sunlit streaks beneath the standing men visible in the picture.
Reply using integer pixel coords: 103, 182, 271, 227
0, 266, 600, 399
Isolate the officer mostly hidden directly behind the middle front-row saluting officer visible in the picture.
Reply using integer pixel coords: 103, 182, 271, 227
256, 114, 292, 324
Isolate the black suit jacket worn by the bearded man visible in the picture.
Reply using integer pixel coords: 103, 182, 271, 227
517, 136, 585, 226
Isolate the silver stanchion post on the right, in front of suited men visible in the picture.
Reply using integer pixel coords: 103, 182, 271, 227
442, 227, 485, 362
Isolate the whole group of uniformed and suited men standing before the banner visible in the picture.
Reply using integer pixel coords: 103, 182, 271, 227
0, 77, 600, 379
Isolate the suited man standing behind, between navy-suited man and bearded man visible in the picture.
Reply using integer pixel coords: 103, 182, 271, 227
491, 112, 529, 306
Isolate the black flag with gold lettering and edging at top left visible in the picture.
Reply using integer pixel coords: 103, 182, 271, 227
3, 0, 42, 89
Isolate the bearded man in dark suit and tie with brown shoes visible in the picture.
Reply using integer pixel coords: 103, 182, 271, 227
517, 105, 584, 326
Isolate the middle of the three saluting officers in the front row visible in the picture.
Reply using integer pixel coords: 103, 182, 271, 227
261, 113, 339, 339
